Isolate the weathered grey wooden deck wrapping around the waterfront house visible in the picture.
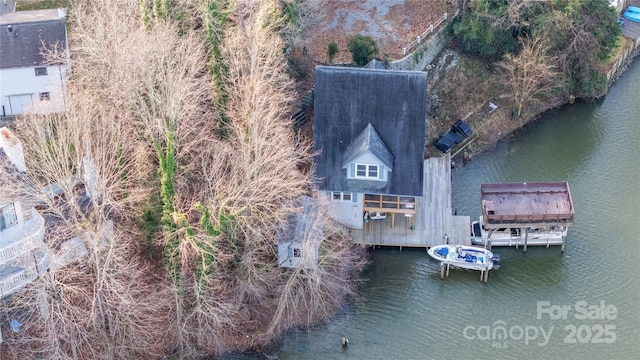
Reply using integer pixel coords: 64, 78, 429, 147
351, 154, 471, 248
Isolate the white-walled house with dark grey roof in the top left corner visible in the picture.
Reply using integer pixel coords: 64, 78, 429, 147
0, 9, 70, 116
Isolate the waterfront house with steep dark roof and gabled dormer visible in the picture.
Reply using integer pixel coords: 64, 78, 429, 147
313, 66, 427, 229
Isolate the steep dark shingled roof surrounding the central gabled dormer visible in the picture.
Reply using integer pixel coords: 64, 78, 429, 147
313, 66, 427, 196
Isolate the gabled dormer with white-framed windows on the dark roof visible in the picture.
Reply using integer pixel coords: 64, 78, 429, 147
342, 123, 393, 185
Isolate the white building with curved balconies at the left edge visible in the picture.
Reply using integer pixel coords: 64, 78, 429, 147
0, 127, 49, 299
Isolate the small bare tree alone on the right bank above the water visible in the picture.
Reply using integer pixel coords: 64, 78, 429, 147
498, 38, 558, 116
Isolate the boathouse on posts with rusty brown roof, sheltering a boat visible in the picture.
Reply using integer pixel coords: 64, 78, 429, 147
480, 181, 575, 252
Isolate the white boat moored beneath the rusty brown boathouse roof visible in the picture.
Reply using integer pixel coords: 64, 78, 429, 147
471, 216, 567, 247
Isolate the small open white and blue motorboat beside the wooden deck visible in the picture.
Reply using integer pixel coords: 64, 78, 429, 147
427, 245, 500, 271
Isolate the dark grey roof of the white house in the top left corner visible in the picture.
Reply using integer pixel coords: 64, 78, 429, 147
0, 9, 67, 69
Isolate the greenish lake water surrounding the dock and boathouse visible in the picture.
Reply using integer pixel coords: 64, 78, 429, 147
228, 57, 640, 359
